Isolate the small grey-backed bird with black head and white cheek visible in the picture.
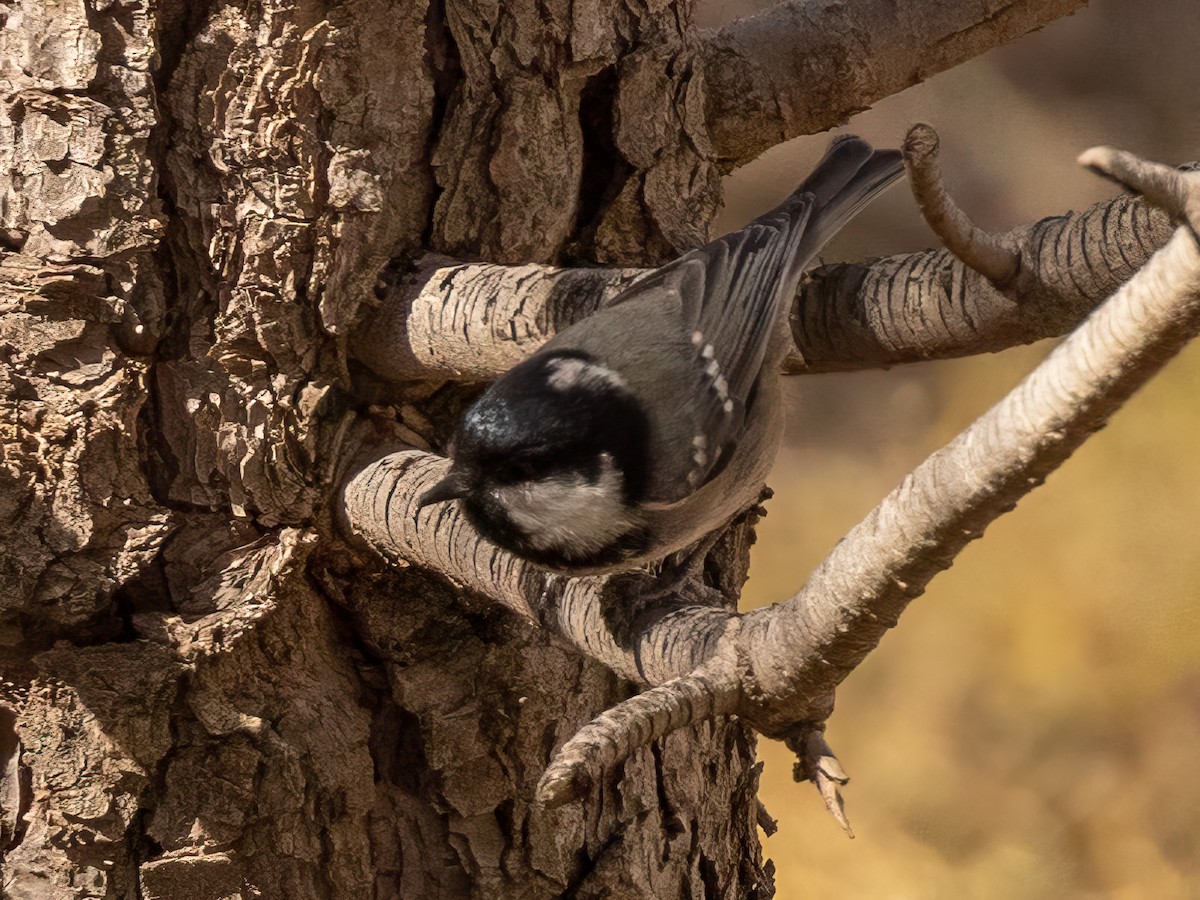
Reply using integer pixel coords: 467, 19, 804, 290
418, 136, 904, 575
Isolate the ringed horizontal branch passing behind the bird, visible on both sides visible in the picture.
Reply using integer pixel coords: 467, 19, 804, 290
353, 196, 1171, 380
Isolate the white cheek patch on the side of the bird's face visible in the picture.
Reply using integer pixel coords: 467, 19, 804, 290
491, 454, 637, 556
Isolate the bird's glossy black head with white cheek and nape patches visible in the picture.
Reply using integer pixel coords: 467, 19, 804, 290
421, 350, 649, 571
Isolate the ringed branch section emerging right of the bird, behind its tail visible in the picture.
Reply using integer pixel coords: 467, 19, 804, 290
787, 176, 1172, 374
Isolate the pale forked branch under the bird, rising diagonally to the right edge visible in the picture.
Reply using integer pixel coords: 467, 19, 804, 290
344, 144, 1200, 830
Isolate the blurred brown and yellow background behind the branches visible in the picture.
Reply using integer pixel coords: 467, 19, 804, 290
700, 0, 1200, 900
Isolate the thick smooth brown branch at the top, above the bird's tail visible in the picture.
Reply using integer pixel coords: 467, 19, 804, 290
698, 0, 1086, 172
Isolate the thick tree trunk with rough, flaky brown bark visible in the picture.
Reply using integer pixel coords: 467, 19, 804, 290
0, 0, 772, 900
